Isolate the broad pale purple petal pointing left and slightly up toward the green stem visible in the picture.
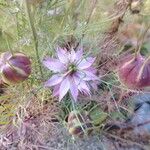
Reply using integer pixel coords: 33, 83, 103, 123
43, 57, 66, 73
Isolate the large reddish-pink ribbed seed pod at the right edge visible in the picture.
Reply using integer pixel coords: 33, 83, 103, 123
118, 54, 150, 89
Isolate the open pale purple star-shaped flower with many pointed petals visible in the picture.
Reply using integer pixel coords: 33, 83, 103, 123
43, 48, 98, 101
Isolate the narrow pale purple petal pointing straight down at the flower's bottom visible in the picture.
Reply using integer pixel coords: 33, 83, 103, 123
70, 82, 78, 101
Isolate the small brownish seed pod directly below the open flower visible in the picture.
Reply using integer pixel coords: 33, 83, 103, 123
68, 111, 93, 138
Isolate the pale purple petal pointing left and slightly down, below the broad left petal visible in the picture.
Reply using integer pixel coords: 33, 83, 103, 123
45, 74, 63, 87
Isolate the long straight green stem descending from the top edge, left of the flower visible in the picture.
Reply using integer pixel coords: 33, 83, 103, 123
25, 0, 43, 78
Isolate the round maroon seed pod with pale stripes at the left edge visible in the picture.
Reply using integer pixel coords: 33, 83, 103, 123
0, 52, 31, 84
